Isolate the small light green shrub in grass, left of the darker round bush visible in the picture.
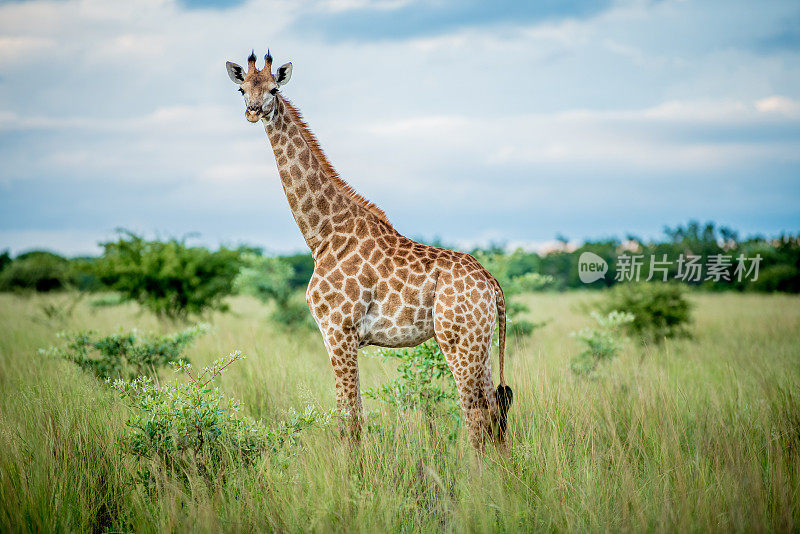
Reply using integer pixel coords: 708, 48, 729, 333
570, 311, 635, 375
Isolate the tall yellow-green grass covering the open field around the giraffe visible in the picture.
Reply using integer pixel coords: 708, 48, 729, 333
0, 293, 800, 532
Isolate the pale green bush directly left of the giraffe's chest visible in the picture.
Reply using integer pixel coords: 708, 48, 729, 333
235, 254, 315, 328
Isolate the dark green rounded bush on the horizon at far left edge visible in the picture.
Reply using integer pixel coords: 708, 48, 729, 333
0, 251, 74, 292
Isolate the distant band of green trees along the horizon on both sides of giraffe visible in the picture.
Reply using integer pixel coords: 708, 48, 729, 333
0, 221, 800, 317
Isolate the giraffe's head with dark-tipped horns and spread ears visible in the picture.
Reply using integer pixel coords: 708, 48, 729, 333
225, 51, 292, 122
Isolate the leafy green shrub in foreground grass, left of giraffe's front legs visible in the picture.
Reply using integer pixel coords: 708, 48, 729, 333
113, 352, 333, 481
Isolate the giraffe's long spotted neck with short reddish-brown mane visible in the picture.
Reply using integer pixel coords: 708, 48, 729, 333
266, 95, 391, 257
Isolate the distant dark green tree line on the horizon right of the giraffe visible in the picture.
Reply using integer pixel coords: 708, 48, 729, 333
260, 221, 800, 293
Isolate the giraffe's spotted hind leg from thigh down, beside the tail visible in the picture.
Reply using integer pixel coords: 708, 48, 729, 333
433, 280, 497, 450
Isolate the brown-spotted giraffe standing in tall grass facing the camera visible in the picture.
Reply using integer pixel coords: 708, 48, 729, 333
226, 51, 513, 450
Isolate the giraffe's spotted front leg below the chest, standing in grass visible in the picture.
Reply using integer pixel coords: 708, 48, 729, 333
324, 330, 364, 442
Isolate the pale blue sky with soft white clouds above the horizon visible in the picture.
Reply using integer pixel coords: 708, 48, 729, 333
0, 0, 800, 254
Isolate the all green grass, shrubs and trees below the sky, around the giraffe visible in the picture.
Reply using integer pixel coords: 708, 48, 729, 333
0, 224, 800, 532
